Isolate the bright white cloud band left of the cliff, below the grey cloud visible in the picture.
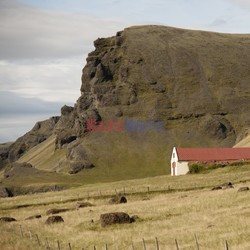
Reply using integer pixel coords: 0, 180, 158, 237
0, 57, 85, 103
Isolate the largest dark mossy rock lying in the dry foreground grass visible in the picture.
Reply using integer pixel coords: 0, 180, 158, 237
100, 212, 131, 227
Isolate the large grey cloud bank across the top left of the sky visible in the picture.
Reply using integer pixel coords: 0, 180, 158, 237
0, 0, 127, 60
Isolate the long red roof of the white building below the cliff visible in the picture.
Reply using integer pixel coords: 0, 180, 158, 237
176, 148, 250, 161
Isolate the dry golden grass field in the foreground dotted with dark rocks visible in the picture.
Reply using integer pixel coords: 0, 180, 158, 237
0, 166, 250, 249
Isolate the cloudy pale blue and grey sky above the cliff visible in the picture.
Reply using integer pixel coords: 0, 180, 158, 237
0, 0, 250, 143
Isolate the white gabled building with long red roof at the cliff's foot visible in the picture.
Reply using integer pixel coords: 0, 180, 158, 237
171, 147, 250, 176
